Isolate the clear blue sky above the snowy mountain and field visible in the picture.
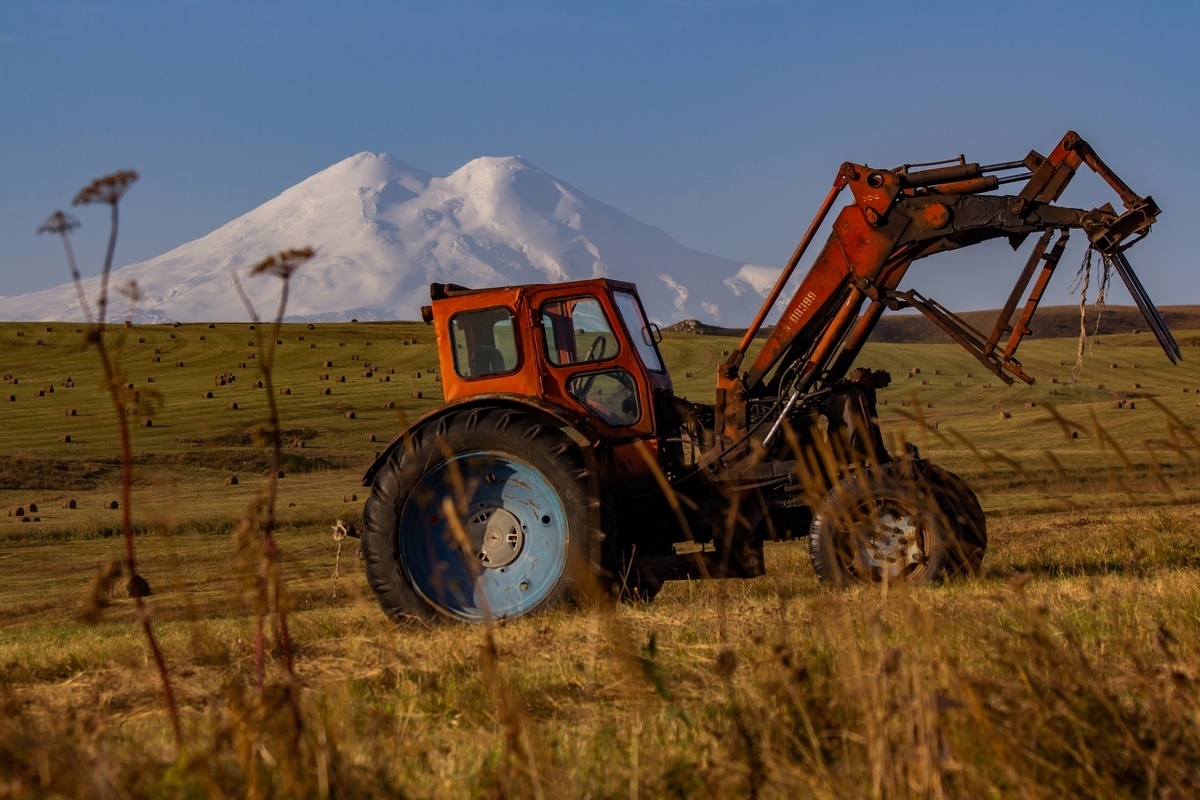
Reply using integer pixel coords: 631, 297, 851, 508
0, 0, 1200, 309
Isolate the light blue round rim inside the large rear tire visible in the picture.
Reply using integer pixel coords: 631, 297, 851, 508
398, 450, 570, 621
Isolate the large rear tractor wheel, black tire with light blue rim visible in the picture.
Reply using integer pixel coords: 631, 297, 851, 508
362, 408, 598, 622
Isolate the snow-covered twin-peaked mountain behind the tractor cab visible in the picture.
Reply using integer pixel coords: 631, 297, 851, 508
0, 152, 778, 325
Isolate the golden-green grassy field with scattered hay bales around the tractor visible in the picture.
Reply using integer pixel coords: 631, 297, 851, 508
0, 323, 1200, 798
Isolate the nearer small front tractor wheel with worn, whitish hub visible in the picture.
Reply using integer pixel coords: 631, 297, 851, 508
809, 462, 953, 588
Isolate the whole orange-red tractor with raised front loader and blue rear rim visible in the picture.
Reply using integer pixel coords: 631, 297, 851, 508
362, 132, 1180, 621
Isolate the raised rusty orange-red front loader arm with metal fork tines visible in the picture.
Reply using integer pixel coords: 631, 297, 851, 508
716, 132, 1180, 462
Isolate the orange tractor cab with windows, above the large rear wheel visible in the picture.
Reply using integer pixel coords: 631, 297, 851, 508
421, 278, 672, 439
